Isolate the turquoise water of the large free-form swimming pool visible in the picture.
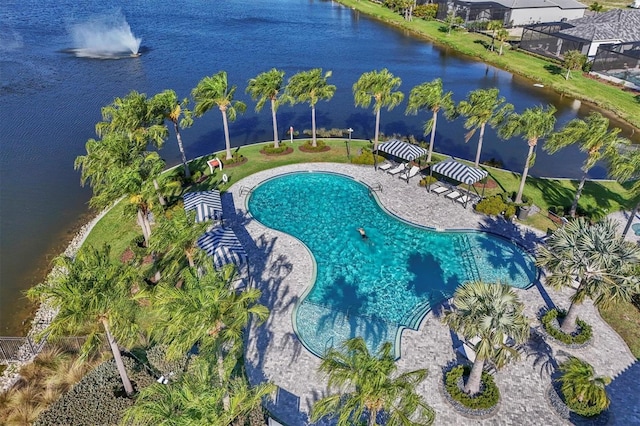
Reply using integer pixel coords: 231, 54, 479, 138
248, 173, 537, 356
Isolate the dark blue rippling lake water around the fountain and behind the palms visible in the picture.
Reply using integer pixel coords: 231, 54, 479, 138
0, 0, 628, 334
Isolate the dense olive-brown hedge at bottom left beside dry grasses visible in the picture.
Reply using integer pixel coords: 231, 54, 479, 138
34, 357, 154, 426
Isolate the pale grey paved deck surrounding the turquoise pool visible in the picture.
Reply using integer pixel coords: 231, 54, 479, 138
223, 163, 640, 426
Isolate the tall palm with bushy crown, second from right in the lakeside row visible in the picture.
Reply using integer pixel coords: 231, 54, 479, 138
544, 112, 630, 217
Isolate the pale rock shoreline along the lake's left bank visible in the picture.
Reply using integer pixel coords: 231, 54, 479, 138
0, 208, 110, 393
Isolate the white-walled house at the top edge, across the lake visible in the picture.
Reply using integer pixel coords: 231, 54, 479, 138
436, 0, 587, 27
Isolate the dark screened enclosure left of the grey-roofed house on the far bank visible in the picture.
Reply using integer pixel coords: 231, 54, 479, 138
520, 22, 591, 60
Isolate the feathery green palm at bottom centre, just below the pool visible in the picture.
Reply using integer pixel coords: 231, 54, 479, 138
311, 337, 435, 426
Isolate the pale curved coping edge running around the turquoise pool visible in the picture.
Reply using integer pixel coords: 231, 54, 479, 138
236, 163, 540, 360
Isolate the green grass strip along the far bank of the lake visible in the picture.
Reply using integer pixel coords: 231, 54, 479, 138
338, 0, 640, 128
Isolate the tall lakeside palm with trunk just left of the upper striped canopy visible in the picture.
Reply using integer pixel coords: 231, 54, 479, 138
353, 68, 404, 150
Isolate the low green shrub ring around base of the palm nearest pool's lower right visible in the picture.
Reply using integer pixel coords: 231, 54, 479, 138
445, 365, 500, 410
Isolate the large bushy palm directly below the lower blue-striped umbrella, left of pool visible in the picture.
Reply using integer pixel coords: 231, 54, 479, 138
154, 262, 269, 410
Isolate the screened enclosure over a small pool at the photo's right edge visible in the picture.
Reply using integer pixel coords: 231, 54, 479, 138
591, 41, 640, 90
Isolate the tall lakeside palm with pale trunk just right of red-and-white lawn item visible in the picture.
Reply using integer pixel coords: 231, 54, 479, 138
191, 71, 247, 160
